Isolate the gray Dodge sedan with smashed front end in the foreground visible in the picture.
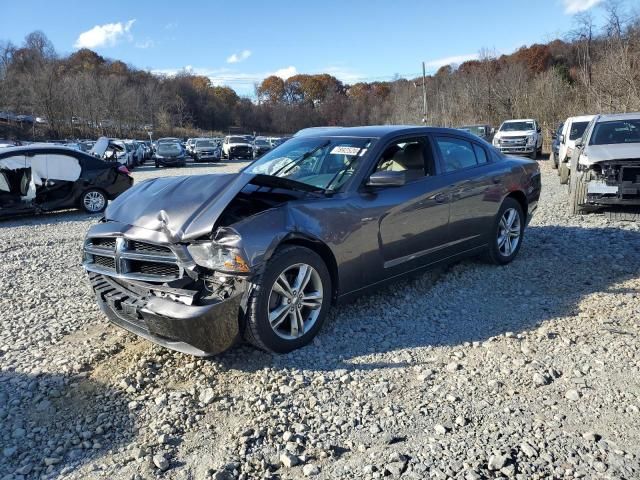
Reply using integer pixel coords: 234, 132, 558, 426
84, 126, 540, 355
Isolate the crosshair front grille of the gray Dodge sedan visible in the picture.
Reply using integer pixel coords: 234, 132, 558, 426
84, 237, 183, 283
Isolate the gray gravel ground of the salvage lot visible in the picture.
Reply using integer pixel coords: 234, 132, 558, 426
0, 161, 640, 480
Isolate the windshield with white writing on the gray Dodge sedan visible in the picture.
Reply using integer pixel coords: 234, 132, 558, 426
247, 137, 371, 190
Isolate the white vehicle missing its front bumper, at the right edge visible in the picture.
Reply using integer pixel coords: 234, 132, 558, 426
569, 113, 640, 214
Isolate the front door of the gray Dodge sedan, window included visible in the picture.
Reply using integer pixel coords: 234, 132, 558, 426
352, 136, 449, 283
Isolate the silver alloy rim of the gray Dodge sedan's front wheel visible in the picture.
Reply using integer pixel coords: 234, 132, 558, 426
269, 263, 323, 340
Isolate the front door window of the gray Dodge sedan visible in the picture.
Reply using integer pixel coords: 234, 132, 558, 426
375, 138, 433, 182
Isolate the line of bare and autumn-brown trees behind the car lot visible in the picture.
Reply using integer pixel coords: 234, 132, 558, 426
0, 2, 640, 142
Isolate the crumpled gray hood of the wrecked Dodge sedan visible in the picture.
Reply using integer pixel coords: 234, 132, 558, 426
105, 173, 254, 242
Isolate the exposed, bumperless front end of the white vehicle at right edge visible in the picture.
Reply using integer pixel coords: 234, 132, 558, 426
578, 160, 640, 205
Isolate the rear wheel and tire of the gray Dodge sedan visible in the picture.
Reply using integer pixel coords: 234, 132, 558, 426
487, 197, 526, 265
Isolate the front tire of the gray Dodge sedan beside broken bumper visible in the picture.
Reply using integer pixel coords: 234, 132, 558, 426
245, 245, 332, 353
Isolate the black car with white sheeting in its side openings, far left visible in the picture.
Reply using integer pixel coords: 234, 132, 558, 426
0, 145, 133, 216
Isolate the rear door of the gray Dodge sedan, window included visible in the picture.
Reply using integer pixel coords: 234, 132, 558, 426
433, 134, 506, 253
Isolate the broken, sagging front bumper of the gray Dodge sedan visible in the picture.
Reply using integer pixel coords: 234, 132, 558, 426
89, 272, 244, 357
